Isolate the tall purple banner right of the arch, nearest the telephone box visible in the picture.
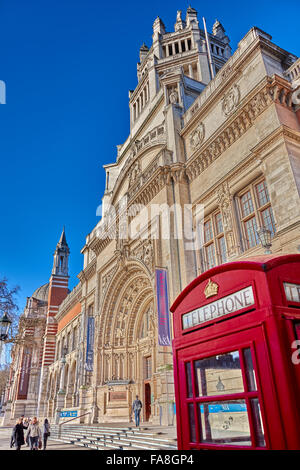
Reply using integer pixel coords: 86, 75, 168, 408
155, 268, 171, 346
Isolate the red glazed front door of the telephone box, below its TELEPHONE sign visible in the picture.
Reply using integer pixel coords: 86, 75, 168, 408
177, 327, 284, 450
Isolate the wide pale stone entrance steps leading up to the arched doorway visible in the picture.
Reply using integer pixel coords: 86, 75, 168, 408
49, 424, 177, 450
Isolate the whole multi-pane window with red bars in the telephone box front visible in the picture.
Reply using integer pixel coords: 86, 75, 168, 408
185, 347, 266, 448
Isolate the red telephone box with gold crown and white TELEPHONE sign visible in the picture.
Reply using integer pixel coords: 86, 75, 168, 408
171, 255, 300, 450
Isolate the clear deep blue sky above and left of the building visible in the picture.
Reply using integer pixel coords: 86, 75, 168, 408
0, 0, 300, 316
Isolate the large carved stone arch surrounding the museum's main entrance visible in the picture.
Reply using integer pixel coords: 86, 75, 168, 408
98, 261, 157, 422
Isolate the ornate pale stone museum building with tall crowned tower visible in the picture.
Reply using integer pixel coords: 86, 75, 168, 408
5, 7, 300, 425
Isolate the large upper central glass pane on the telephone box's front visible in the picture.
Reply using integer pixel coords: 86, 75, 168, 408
195, 351, 244, 397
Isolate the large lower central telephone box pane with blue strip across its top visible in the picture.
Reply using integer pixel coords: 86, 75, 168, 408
198, 400, 251, 446
